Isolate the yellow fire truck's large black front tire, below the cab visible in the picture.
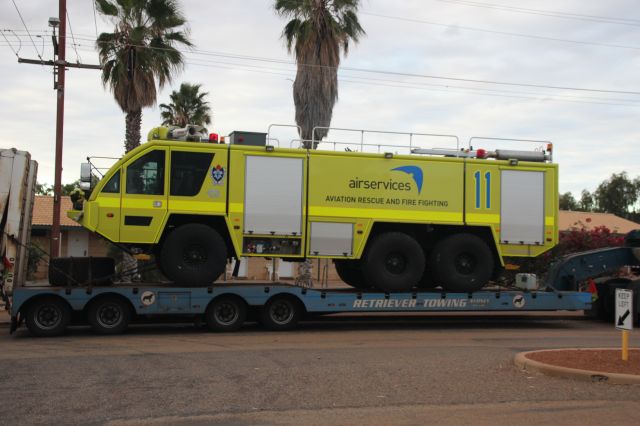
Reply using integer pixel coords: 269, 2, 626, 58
160, 223, 227, 285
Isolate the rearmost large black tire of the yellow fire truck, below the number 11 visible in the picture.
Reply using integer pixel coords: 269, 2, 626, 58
429, 233, 495, 293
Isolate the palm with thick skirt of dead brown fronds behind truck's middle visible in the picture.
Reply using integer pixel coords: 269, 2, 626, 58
275, 0, 365, 148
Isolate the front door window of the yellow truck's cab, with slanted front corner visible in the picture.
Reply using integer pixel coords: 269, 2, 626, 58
127, 150, 165, 195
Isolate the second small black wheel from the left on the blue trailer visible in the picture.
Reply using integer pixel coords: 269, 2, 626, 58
87, 296, 131, 334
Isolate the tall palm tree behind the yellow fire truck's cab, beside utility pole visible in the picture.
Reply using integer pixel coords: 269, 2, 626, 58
96, 0, 192, 152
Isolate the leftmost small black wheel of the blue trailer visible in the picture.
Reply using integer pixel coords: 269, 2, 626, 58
25, 297, 71, 337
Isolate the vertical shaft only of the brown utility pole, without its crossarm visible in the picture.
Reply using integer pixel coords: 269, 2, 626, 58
49, 0, 67, 258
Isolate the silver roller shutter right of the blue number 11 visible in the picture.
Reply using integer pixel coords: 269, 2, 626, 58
500, 170, 544, 244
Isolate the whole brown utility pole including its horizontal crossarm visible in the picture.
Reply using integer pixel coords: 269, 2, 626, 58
18, 0, 102, 258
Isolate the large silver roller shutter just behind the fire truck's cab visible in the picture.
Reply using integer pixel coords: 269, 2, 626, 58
244, 155, 304, 235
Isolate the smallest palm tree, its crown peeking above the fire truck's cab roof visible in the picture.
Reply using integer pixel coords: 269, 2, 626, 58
160, 83, 211, 127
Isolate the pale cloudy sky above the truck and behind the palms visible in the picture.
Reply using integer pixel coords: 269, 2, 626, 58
0, 0, 640, 197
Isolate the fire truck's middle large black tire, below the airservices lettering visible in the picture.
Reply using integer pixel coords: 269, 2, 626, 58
362, 232, 425, 293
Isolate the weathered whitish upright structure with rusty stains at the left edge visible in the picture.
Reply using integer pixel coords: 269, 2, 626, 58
0, 148, 38, 305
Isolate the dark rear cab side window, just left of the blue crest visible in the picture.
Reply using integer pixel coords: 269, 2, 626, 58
170, 151, 213, 197
